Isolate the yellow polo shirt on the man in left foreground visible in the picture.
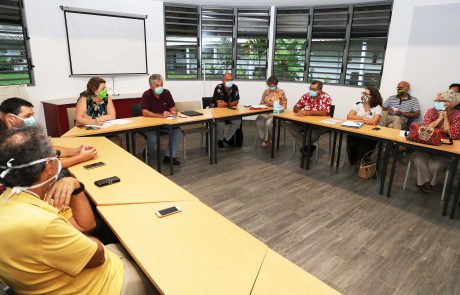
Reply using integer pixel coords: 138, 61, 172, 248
0, 189, 123, 294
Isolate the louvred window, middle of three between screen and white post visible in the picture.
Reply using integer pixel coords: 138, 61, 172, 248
201, 7, 235, 80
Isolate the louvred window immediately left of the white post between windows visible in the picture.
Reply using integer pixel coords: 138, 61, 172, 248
235, 9, 270, 80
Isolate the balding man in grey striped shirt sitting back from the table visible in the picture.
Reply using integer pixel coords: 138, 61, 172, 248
382, 81, 420, 130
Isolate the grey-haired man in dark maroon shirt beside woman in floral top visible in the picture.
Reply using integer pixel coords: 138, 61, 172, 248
141, 74, 180, 165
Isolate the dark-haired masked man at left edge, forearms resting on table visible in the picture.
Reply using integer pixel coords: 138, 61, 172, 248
0, 97, 97, 168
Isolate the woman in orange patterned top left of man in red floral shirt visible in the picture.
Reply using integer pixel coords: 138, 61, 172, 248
256, 76, 287, 148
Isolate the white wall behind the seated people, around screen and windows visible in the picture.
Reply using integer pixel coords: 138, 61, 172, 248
25, 0, 460, 125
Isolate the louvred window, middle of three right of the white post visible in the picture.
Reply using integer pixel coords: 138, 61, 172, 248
308, 7, 348, 84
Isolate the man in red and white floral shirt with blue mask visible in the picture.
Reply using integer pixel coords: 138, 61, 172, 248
289, 80, 332, 156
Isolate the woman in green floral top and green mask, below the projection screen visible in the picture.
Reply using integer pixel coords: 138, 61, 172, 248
75, 77, 116, 125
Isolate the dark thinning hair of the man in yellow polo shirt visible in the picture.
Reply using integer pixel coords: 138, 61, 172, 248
0, 126, 54, 187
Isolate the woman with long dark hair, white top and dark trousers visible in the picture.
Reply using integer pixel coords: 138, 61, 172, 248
347, 86, 382, 165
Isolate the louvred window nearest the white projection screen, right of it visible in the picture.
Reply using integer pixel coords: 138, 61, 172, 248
165, 5, 199, 79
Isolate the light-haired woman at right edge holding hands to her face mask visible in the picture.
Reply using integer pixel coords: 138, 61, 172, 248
413, 91, 460, 193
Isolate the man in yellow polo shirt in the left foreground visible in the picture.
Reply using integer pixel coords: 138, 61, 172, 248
0, 127, 153, 294
